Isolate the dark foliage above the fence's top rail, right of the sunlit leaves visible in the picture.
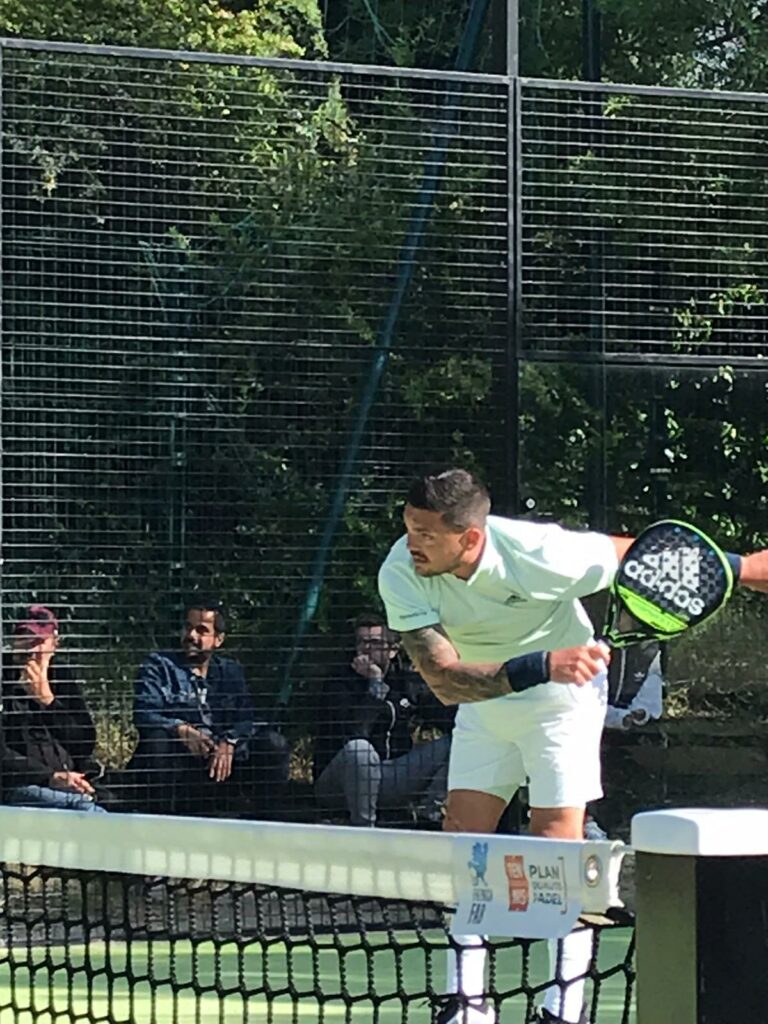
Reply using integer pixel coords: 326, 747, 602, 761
325, 0, 768, 90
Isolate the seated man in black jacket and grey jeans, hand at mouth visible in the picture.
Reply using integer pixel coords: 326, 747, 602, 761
314, 614, 455, 825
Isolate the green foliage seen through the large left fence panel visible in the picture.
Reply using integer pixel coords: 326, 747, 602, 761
5, 19, 507, 712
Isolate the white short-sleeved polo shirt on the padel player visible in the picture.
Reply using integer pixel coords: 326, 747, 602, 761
379, 516, 618, 664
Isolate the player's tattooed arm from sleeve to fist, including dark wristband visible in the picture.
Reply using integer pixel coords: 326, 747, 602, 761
401, 624, 608, 705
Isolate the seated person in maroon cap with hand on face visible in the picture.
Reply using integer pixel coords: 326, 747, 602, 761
2, 604, 104, 812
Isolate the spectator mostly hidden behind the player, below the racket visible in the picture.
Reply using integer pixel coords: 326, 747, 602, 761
584, 640, 664, 839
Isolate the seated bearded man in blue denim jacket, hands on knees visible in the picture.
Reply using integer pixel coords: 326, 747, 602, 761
129, 601, 289, 814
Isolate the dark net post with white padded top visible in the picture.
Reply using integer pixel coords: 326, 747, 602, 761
632, 809, 768, 1024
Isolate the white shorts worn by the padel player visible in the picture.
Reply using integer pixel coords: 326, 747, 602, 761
449, 672, 607, 807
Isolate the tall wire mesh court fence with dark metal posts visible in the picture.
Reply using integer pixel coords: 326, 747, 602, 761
0, 41, 768, 817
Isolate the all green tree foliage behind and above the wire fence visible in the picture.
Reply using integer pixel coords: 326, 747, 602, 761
0, 0, 768, 720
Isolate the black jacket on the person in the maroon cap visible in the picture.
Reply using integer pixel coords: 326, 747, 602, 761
0, 657, 96, 791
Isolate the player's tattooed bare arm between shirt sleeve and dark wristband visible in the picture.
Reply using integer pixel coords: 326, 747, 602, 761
401, 624, 512, 705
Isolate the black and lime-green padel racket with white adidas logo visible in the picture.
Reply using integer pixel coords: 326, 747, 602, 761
603, 519, 734, 647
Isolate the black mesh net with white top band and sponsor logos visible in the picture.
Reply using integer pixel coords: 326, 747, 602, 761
0, 808, 634, 1024
